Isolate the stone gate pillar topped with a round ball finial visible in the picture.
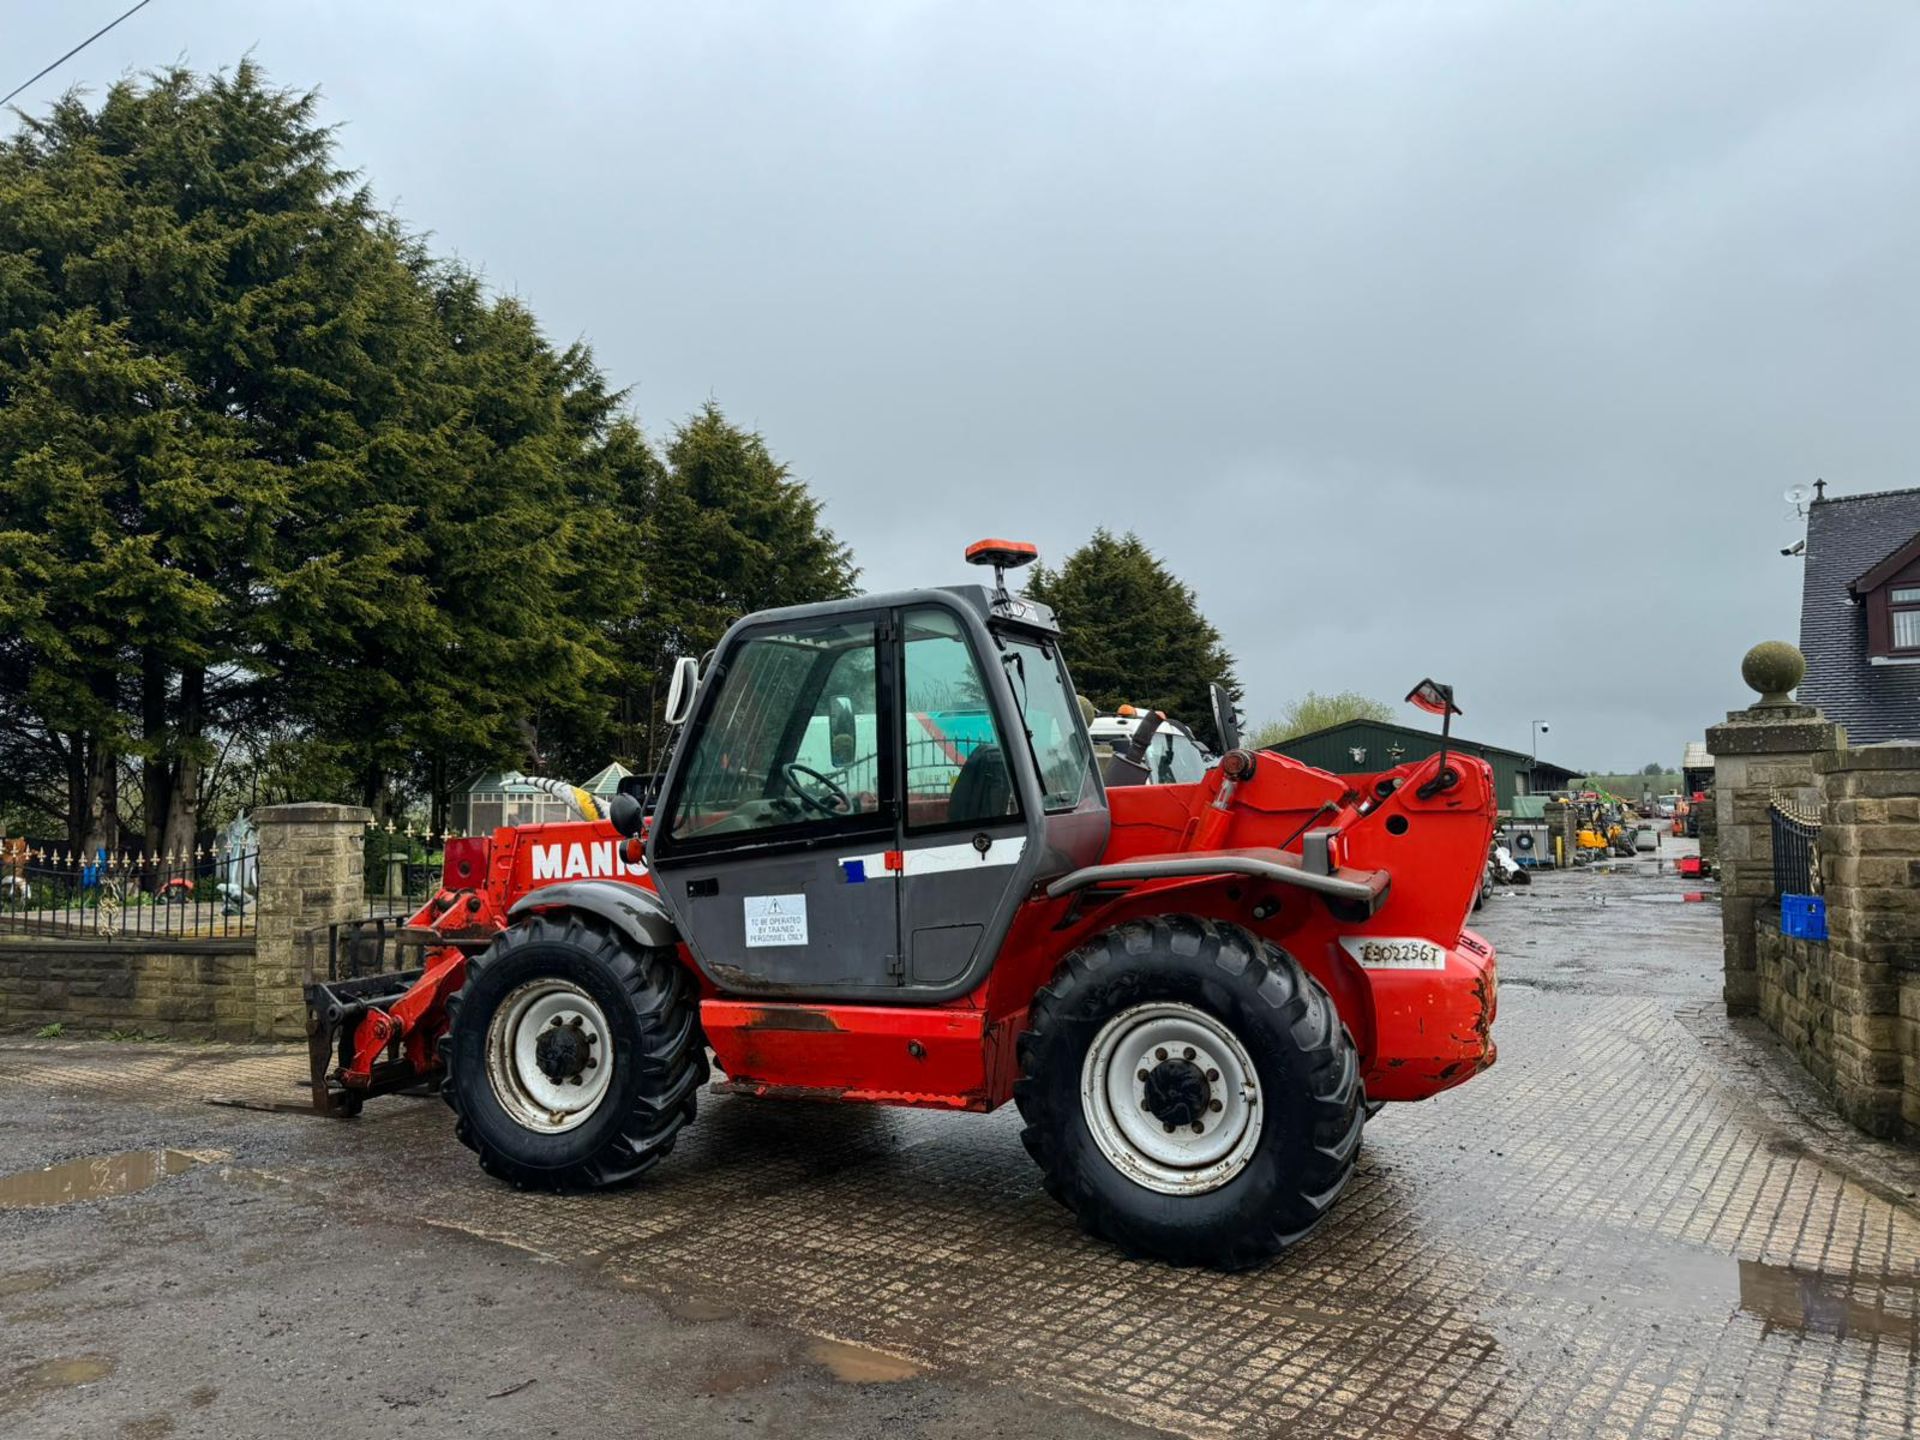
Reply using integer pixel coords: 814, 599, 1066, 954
1707, 639, 1847, 1016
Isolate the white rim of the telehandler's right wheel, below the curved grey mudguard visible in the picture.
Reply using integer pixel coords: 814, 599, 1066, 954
1081, 1002, 1260, 1194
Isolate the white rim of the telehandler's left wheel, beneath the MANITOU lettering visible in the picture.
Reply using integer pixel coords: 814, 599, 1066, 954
486, 977, 612, 1135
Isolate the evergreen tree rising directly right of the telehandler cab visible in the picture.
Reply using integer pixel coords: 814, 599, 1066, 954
1025, 528, 1240, 743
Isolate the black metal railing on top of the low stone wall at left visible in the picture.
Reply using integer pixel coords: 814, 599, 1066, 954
0, 847, 259, 939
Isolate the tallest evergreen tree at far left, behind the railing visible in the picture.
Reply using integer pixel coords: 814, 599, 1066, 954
0, 63, 435, 849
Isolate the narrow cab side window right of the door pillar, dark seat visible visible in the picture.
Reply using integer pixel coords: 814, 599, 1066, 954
900, 605, 1020, 829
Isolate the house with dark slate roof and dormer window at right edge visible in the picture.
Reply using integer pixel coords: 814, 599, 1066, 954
1799, 480, 1920, 745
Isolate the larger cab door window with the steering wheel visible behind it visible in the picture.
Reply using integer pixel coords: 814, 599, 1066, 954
664, 620, 891, 841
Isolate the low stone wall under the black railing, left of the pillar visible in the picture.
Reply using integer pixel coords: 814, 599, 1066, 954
0, 941, 253, 1041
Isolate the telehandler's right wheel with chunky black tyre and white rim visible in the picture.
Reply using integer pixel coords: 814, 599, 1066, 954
1014, 916, 1365, 1269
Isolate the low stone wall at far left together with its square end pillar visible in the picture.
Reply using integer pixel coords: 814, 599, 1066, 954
0, 804, 367, 1041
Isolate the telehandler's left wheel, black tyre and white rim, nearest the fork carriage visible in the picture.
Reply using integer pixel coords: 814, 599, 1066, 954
440, 912, 707, 1190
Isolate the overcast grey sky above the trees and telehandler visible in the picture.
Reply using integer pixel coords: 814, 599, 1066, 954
0, 0, 1920, 768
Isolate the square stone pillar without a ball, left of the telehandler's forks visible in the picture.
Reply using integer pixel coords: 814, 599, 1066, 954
253, 804, 372, 1041
